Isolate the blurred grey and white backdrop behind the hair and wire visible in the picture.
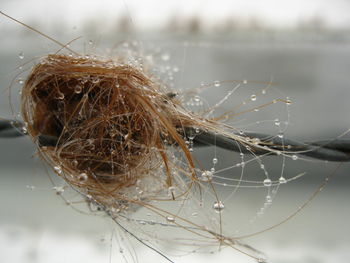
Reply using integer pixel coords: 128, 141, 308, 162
0, 0, 350, 263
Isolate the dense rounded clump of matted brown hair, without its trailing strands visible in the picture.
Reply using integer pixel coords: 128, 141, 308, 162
22, 54, 198, 211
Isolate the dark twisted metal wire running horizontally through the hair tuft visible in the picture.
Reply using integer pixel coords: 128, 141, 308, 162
0, 120, 350, 162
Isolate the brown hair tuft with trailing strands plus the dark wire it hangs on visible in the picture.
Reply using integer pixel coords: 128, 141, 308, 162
0, 12, 350, 261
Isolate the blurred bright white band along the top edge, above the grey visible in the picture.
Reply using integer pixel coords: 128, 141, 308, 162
1, 0, 350, 29
